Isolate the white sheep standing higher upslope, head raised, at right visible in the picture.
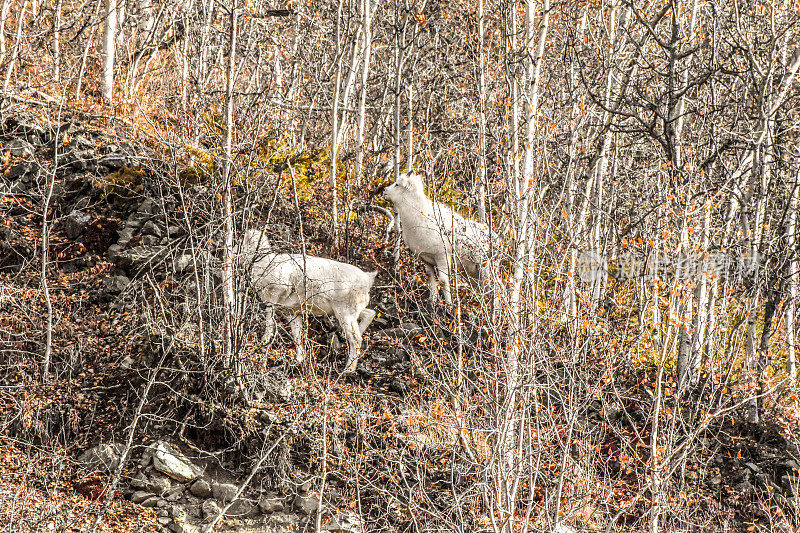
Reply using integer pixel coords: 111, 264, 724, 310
383, 174, 490, 304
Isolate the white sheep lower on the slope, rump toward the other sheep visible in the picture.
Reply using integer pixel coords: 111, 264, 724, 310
237, 229, 377, 373
